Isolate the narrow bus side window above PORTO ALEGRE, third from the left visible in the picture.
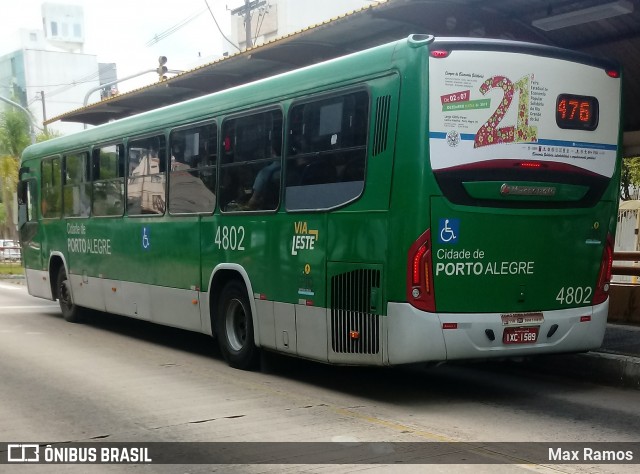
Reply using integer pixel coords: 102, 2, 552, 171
91, 144, 125, 216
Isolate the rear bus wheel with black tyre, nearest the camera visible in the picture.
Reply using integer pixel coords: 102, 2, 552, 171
216, 281, 259, 370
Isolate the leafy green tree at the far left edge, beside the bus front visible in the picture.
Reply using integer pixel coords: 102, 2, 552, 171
0, 108, 30, 240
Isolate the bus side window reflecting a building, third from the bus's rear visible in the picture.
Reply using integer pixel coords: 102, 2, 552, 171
169, 123, 217, 214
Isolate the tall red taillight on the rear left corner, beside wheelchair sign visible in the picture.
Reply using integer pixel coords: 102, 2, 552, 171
407, 229, 436, 312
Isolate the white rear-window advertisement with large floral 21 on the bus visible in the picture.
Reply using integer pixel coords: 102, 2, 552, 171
429, 50, 620, 177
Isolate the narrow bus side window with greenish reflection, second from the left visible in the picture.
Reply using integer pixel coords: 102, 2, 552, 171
62, 152, 91, 217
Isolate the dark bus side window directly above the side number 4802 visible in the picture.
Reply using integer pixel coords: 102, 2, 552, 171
219, 110, 282, 212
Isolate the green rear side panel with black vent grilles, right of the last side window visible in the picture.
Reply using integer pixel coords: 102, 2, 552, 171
324, 74, 400, 364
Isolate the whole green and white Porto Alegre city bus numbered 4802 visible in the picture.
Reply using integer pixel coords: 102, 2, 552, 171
18, 35, 621, 369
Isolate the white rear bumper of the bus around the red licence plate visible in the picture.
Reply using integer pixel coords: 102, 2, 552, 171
386, 300, 609, 365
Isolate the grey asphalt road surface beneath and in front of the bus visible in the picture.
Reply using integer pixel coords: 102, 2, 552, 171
0, 282, 640, 473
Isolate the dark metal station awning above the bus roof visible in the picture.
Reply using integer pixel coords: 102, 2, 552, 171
47, 0, 640, 130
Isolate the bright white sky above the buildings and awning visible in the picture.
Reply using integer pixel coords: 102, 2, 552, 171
0, 0, 236, 92
